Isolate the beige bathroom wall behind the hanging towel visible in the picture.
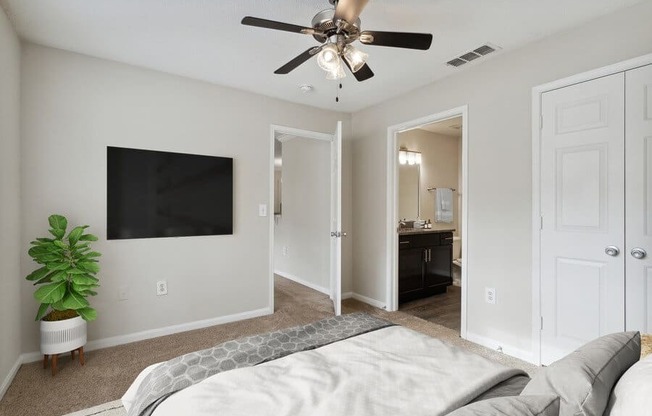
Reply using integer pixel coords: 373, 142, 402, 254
398, 129, 461, 230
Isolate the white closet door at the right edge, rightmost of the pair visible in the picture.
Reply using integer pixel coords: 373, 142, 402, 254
623, 65, 652, 333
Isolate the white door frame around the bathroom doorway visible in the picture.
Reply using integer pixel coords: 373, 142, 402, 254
385, 105, 469, 338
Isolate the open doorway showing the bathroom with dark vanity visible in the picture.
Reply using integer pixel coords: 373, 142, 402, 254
388, 107, 467, 337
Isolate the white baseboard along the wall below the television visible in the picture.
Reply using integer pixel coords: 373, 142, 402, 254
20, 307, 274, 363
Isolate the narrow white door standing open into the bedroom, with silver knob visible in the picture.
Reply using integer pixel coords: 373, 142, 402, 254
331, 121, 346, 316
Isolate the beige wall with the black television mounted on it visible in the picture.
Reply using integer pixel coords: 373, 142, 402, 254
20, 44, 351, 352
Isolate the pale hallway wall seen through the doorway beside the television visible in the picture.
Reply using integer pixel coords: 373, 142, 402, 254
274, 137, 331, 293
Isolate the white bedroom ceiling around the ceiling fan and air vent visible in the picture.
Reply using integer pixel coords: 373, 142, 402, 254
0, 0, 644, 112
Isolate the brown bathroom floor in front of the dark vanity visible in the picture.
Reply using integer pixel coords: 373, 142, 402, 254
398, 286, 462, 332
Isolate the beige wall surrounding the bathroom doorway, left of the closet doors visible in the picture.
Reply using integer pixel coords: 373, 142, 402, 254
353, 2, 652, 355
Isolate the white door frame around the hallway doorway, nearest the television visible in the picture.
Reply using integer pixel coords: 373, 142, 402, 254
267, 124, 341, 313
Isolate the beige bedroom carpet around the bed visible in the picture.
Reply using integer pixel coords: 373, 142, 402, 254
0, 278, 536, 416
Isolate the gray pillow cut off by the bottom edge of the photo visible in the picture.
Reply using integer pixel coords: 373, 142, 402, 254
448, 394, 559, 416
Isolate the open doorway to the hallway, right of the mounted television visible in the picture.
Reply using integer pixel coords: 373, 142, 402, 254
270, 123, 341, 314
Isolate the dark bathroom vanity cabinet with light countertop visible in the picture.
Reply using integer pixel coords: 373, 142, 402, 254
398, 229, 454, 303
